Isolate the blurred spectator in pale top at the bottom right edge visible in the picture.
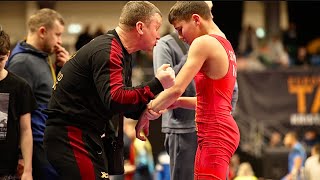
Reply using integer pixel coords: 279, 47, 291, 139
305, 144, 320, 180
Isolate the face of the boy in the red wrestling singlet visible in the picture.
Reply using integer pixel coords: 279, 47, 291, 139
173, 18, 197, 45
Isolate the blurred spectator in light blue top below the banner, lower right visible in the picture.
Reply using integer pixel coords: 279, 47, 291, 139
282, 131, 307, 180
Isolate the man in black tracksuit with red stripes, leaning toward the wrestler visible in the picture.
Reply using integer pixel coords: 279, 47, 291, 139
44, 1, 174, 180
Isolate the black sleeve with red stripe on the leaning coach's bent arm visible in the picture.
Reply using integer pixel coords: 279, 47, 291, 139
91, 39, 163, 116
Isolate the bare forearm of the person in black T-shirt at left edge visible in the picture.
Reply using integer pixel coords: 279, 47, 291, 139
20, 113, 33, 180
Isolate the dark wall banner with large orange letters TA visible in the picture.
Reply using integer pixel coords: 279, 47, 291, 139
237, 68, 320, 131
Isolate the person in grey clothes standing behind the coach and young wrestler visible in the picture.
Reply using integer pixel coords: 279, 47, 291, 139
153, 26, 197, 180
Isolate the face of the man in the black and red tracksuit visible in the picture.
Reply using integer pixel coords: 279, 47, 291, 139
141, 13, 162, 51
